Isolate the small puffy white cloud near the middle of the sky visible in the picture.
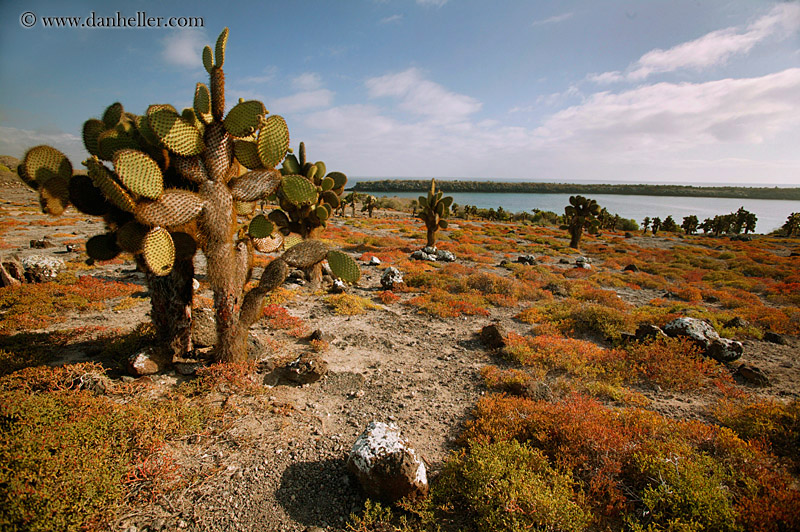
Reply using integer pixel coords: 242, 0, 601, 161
366, 68, 481, 122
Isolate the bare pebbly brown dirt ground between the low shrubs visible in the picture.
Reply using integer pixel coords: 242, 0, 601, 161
0, 180, 800, 532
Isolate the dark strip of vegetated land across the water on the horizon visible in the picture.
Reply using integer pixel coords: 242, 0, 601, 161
350, 179, 800, 200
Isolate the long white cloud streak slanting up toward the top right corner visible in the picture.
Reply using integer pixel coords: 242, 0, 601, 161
587, 3, 800, 83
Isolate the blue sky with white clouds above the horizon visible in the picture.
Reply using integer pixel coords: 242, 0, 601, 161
0, 0, 800, 186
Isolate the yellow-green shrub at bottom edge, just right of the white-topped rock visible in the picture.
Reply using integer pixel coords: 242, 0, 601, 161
435, 440, 589, 531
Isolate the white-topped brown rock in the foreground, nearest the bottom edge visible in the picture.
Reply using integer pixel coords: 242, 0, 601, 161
347, 421, 428, 504
